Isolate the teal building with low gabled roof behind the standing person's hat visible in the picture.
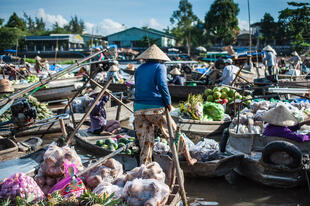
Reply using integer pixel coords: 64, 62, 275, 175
107, 27, 176, 49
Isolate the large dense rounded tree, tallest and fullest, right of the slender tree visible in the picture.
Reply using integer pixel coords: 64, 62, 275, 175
205, 0, 240, 45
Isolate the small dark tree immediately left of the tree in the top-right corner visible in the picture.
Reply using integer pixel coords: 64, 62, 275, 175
260, 13, 278, 44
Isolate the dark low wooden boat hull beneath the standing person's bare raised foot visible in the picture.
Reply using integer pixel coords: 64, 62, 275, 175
153, 154, 243, 178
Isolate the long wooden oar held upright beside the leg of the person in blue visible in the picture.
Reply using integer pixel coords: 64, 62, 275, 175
165, 108, 188, 206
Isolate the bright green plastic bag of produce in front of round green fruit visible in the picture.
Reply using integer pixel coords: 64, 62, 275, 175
203, 102, 224, 121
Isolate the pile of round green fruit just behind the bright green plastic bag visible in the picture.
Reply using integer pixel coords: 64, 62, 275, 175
204, 86, 252, 104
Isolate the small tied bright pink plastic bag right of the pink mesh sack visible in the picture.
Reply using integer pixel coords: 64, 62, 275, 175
48, 161, 86, 198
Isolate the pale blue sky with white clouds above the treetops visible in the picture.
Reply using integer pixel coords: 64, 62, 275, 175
0, 0, 300, 35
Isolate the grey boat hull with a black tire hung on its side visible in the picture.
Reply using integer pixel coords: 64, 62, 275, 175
226, 130, 310, 188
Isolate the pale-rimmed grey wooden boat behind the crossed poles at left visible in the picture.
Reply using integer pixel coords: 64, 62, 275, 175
13, 78, 83, 101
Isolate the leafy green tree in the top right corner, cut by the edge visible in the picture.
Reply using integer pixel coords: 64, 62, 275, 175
278, 2, 310, 50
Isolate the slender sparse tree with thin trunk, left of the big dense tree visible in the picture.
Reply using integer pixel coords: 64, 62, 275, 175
170, 0, 198, 56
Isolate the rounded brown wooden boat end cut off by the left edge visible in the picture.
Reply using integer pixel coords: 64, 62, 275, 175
0, 138, 18, 161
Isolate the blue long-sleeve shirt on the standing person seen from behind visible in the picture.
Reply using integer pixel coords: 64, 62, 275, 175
135, 62, 171, 107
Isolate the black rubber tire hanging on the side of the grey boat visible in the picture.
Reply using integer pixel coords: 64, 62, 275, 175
262, 141, 302, 168
